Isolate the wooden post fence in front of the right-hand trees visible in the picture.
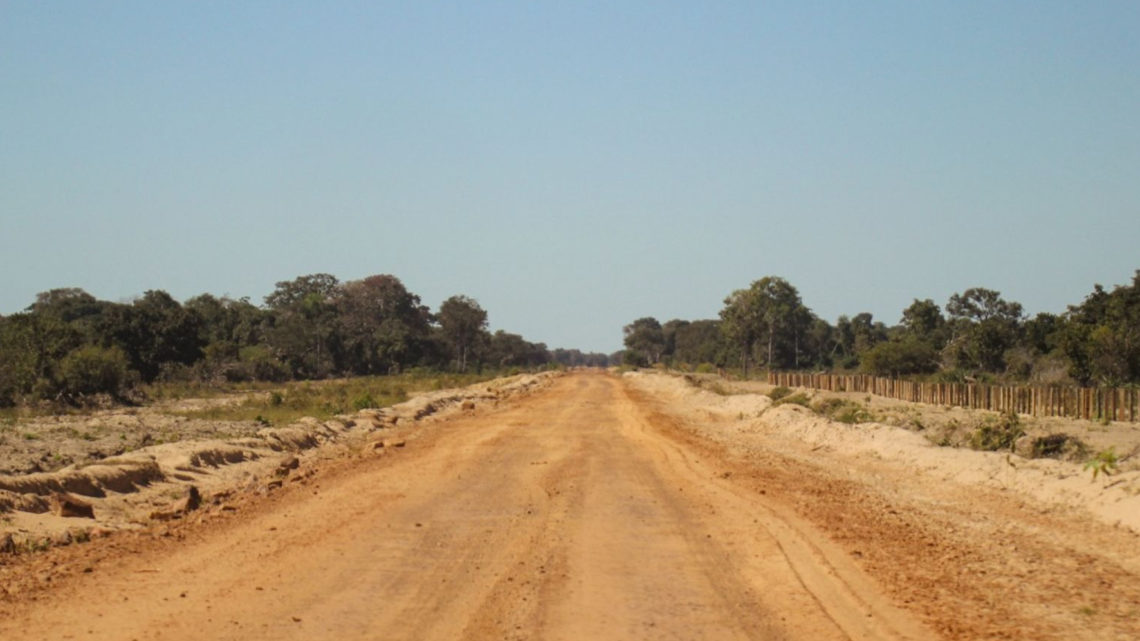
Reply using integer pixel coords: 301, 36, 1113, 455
768, 372, 1140, 422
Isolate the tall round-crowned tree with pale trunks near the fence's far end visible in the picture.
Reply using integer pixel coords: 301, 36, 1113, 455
720, 276, 812, 376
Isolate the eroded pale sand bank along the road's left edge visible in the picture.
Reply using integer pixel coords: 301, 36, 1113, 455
0, 373, 557, 541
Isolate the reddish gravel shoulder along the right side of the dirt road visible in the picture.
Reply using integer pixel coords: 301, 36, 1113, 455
630, 374, 1140, 641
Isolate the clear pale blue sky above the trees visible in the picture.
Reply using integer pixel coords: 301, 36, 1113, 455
0, 0, 1140, 352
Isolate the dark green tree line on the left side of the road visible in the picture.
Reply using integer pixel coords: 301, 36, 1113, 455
0, 274, 609, 406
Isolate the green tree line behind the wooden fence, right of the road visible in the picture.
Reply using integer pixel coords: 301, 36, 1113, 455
622, 270, 1140, 387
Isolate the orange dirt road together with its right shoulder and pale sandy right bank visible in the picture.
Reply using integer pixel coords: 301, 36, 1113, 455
0, 373, 1140, 640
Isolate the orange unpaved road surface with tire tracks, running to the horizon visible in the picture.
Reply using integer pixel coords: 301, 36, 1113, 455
0, 373, 1140, 641
